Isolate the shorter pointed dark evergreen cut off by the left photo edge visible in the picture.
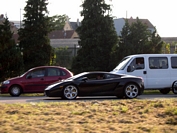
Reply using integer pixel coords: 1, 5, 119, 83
0, 17, 23, 81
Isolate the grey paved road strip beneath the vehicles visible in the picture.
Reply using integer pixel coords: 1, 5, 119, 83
0, 94, 177, 103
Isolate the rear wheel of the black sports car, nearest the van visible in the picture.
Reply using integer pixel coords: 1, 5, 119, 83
124, 83, 139, 99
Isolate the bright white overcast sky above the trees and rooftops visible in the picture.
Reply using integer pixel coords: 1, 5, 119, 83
0, 0, 177, 37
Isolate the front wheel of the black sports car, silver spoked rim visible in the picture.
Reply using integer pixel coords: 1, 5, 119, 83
63, 85, 78, 100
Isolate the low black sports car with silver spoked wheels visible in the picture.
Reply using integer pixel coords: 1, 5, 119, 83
44, 72, 144, 100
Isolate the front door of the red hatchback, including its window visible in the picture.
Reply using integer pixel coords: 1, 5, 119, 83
23, 68, 46, 93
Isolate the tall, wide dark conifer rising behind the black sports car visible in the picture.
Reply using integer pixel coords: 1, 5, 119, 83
72, 0, 118, 73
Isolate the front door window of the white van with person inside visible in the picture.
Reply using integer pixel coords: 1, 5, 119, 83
130, 57, 144, 70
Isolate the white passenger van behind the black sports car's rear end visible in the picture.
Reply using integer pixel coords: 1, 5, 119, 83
112, 54, 177, 94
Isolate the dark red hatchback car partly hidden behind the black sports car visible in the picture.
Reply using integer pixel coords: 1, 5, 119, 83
0, 66, 73, 96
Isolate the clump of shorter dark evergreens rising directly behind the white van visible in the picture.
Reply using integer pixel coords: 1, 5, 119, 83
112, 17, 163, 66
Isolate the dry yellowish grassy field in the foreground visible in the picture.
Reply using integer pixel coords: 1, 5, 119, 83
0, 99, 177, 133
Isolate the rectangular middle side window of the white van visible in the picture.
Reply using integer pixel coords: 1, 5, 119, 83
149, 57, 168, 69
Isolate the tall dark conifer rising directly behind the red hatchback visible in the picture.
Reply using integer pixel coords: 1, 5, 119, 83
19, 0, 52, 70
